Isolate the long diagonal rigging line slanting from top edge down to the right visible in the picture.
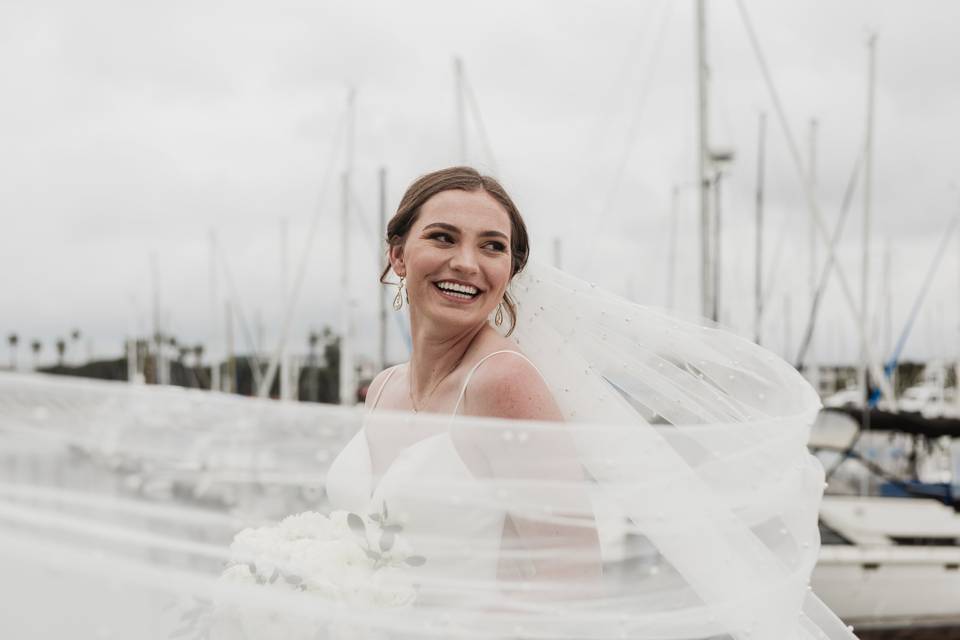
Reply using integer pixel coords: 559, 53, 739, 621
737, 0, 894, 400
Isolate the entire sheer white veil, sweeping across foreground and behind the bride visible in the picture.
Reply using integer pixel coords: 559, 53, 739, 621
0, 264, 853, 640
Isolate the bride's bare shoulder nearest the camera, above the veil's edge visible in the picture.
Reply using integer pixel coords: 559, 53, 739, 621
464, 348, 562, 421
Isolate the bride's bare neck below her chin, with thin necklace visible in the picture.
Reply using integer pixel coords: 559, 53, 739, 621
410, 317, 488, 397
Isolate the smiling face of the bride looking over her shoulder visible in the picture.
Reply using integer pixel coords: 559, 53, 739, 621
390, 189, 511, 327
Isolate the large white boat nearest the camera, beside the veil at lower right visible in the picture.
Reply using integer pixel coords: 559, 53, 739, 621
810, 412, 960, 637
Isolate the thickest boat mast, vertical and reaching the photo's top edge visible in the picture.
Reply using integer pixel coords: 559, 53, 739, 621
696, 0, 716, 320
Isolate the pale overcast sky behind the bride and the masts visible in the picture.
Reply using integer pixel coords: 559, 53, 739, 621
0, 0, 960, 368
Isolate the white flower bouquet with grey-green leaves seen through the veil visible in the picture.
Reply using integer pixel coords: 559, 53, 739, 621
176, 504, 426, 639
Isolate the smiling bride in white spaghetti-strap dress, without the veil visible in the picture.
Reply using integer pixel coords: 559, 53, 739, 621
327, 167, 600, 606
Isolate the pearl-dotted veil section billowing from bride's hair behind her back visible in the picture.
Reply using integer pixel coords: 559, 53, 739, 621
502, 263, 853, 638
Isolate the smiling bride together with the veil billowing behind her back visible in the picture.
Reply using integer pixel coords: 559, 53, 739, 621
327, 167, 852, 638
